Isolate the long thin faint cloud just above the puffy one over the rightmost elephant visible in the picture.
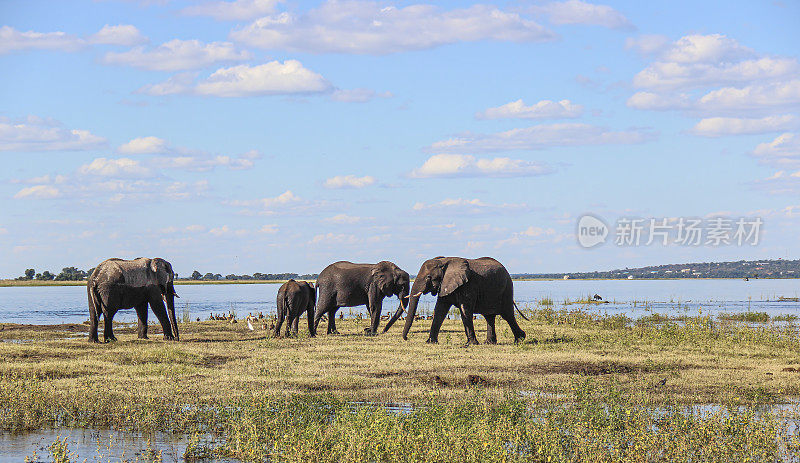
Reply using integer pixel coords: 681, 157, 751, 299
428, 123, 654, 153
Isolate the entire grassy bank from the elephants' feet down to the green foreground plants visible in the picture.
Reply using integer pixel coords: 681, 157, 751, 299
0, 307, 800, 461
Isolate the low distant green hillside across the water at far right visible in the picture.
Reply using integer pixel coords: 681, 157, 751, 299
512, 259, 800, 280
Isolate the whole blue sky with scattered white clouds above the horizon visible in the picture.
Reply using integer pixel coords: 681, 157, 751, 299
0, 0, 800, 277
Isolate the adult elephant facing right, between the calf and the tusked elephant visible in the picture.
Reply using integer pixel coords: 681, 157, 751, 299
314, 261, 411, 335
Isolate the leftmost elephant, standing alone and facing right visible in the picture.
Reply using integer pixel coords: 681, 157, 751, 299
86, 257, 180, 342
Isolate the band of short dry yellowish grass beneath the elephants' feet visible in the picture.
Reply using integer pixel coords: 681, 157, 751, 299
0, 320, 800, 403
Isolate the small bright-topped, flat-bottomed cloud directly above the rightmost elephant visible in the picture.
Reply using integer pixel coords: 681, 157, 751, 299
411, 154, 552, 178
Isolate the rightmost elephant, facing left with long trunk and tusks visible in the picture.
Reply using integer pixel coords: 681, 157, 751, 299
383, 257, 525, 344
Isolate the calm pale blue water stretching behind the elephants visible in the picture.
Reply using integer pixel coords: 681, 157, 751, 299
0, 280, 800, 324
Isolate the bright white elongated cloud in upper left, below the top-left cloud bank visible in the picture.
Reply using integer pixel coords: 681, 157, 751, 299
140, 60, 333, 98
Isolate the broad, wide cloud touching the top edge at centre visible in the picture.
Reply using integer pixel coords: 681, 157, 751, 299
231, 0, 556, 55
